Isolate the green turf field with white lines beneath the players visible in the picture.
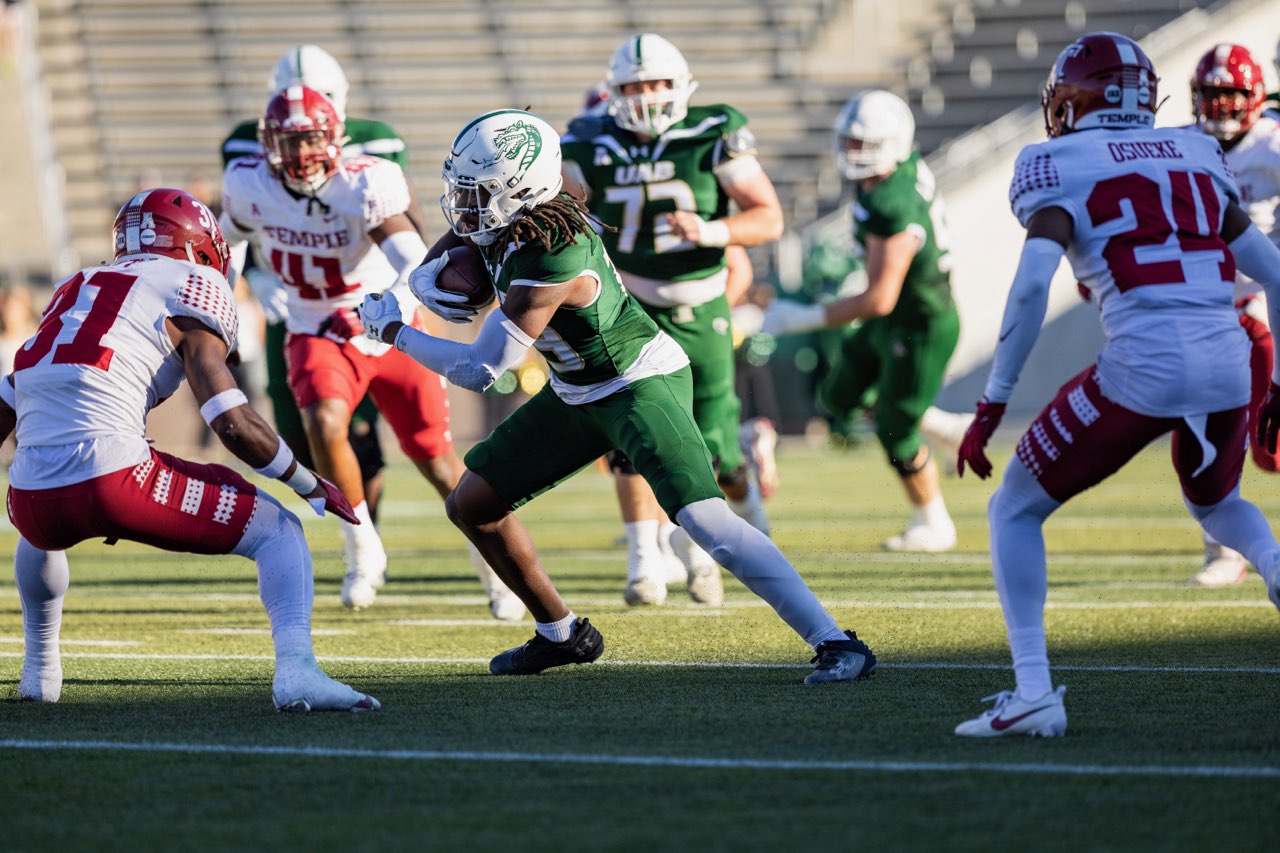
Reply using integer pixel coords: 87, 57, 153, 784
0, 446, 1280, 850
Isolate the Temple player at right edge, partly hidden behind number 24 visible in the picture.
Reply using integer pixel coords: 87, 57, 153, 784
1192, 44, 1280, 587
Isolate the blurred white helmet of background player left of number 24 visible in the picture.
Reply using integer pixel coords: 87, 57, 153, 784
833, 88, 915, 181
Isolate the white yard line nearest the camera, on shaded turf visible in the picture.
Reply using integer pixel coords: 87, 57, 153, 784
0, 740, 1280, 779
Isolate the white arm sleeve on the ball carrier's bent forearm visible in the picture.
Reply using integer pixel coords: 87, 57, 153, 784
396, 309, 534, 393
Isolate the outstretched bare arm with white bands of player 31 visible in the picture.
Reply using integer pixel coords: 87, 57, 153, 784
165, 316, 360, 524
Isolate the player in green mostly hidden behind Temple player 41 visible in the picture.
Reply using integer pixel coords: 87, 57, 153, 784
221, 45, 412, 527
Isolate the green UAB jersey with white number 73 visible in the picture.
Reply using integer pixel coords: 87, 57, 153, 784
561, 104, 755, 282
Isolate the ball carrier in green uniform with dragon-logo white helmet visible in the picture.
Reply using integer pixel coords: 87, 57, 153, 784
360, 110, 876, 684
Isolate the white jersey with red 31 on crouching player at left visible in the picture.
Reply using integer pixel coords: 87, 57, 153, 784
9, 255, 238, 489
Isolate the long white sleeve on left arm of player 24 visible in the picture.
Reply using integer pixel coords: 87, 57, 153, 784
983, 237, 1066, 403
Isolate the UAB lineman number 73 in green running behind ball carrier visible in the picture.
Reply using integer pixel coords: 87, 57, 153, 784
562, 33, 782, 605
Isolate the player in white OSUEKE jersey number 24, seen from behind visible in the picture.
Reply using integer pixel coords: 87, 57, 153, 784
956, 33, 1280, 738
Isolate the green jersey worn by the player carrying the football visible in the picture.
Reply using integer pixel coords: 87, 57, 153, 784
483, 216, 689, 394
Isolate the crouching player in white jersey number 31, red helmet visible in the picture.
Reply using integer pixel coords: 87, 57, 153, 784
0, 190, 379, 711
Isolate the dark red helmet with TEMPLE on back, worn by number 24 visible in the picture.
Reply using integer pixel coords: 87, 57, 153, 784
1041, 32, 1160, 138
